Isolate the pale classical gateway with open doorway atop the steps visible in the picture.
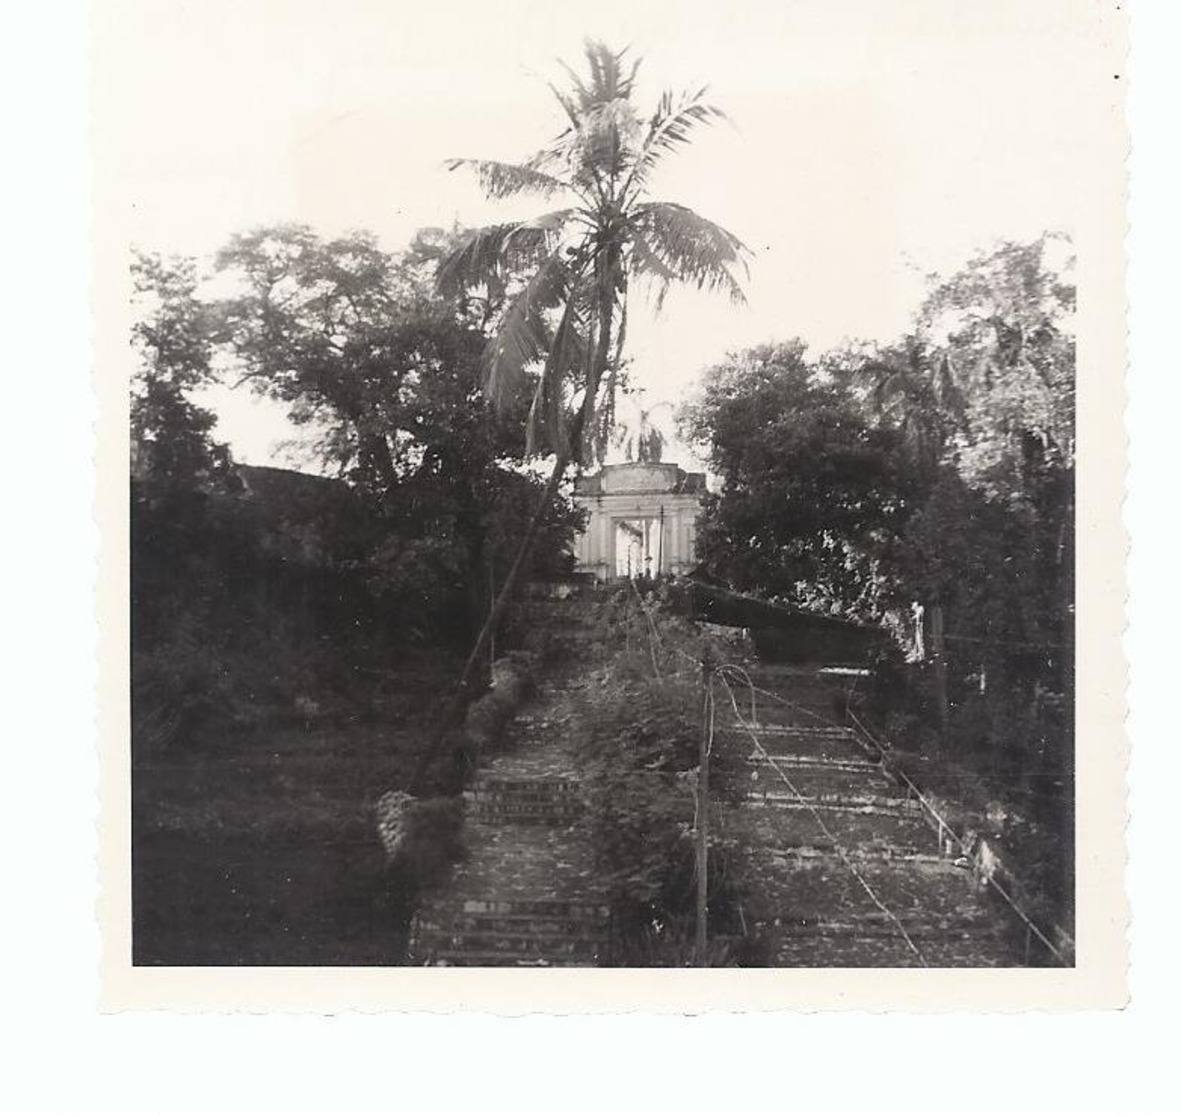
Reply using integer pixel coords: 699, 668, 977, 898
574, 462, 705, 581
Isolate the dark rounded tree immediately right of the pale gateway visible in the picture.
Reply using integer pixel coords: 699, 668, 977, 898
683, 342, 916, 619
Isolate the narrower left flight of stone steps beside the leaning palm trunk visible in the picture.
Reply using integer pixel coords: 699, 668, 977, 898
407, 693, 612, 966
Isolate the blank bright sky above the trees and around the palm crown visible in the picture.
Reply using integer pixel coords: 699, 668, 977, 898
106, 0, 1115, 463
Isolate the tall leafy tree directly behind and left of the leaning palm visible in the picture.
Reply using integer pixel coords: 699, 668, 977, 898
216, 226, 583, 637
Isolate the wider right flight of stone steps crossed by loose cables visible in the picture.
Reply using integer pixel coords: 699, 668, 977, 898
719, 668, 1025, 967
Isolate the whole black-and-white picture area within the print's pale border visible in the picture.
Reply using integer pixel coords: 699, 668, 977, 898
105, 0, 1122, 982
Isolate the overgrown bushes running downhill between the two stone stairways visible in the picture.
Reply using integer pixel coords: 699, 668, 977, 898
575, 587, 752, 966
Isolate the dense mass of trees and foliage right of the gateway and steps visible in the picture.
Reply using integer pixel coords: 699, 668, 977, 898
683, 236, 1075, 916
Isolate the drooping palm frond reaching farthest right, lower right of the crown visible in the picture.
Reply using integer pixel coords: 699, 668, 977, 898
632, 202, 750, 302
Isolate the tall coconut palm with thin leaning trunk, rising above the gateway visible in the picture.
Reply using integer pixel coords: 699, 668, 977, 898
438, 43, 748, 716
